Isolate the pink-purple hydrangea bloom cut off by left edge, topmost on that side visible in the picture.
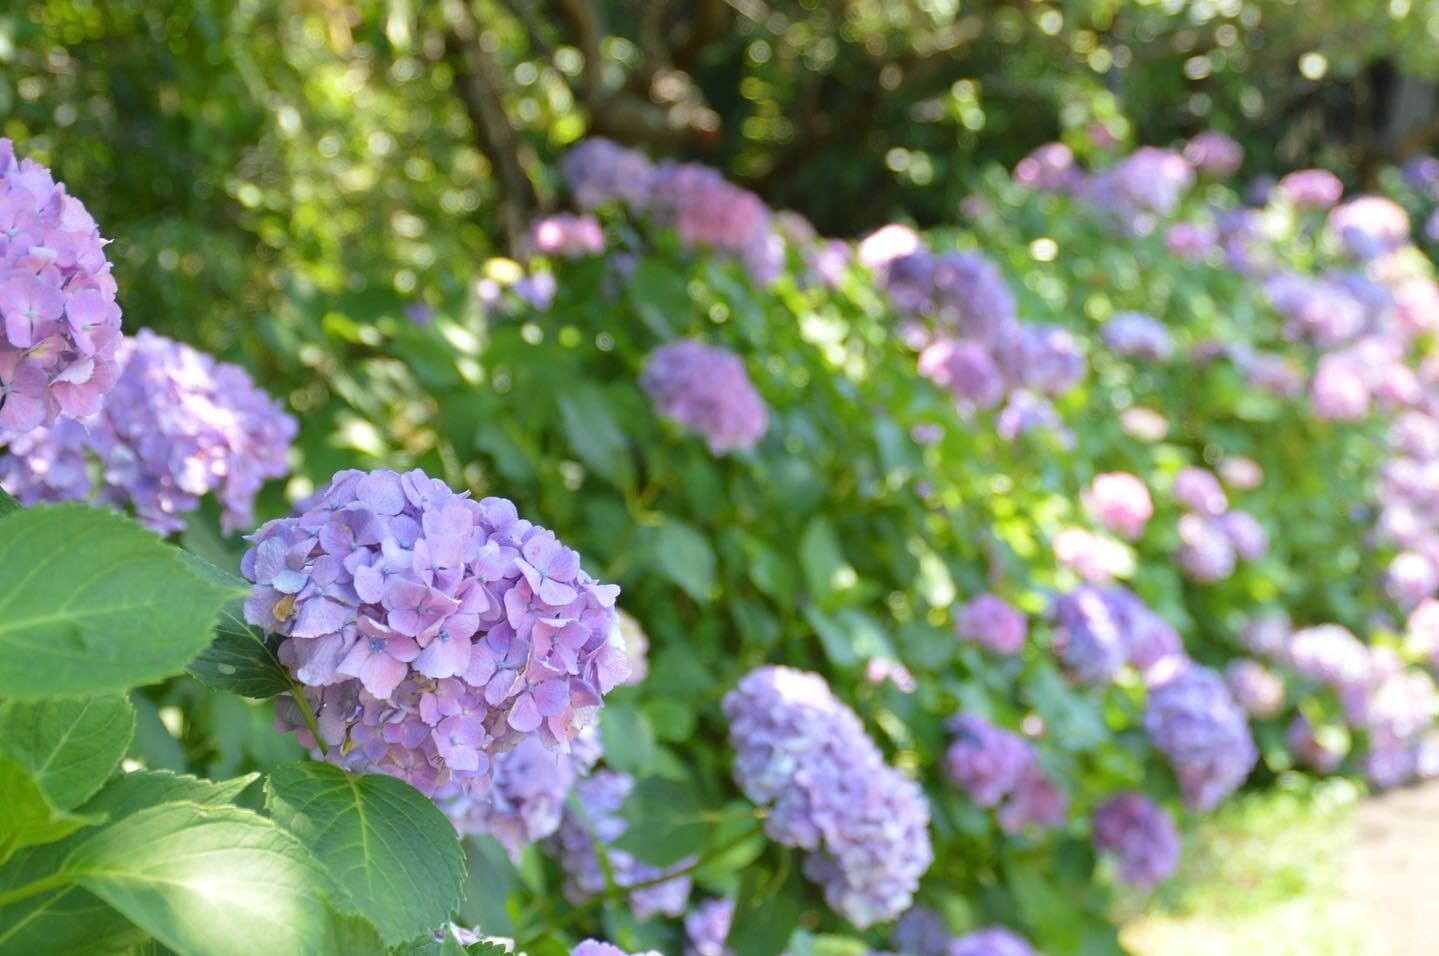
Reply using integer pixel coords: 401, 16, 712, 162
0, 137, 119, 434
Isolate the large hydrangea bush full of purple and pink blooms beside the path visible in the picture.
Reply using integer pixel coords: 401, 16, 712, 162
14, 125, 1439, 956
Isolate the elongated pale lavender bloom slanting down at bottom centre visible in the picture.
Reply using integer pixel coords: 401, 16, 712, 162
724, 667, 932, 929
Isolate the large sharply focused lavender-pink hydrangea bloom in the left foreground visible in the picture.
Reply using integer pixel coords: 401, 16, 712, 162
250, 469, 629, 802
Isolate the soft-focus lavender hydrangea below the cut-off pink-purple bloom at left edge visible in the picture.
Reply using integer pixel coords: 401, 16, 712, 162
0, 328, 296, 533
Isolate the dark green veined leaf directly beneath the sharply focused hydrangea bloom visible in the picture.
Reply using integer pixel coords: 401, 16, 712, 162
265, 762, 465, 946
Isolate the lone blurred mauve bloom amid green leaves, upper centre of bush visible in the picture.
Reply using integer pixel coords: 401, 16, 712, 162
639, 338, 770, 455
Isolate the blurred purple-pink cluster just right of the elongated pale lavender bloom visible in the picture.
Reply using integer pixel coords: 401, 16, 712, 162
944, 714, 1069, 834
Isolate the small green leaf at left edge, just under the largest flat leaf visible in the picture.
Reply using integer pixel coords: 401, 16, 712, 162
0, 694, 135, 811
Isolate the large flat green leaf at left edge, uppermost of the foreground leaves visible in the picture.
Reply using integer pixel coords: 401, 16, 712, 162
0, 504, 229, 700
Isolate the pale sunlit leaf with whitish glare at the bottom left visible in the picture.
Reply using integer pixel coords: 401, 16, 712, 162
59, 803, 338, 956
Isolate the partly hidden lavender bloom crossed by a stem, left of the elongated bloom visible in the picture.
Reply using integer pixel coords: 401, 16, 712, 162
545, 770, 694, 921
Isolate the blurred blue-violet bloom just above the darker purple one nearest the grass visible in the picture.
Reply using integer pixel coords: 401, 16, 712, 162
1144, 665, 1259, 812
